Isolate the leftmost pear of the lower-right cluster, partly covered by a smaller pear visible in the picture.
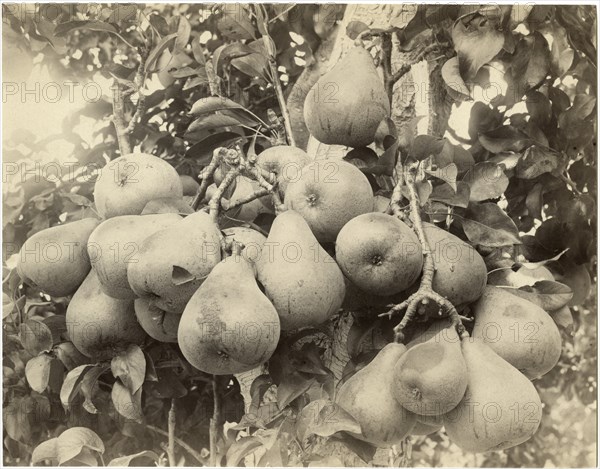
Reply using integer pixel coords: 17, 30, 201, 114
336, 343, 417, 447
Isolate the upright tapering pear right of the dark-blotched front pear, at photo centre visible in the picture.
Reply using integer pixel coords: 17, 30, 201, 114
256, 210, 345, 330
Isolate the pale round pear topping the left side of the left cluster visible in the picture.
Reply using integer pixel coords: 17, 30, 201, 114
94, 153, 183, 218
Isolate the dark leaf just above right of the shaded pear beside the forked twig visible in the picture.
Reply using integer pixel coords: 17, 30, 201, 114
462, 203, 521, 247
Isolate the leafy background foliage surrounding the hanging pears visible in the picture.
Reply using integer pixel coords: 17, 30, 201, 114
3, 4, 597, 466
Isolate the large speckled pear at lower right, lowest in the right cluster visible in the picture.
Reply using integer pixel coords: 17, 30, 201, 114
443, 339, 542, 453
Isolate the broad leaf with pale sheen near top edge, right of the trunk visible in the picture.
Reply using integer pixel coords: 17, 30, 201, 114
452, 15, 504, 82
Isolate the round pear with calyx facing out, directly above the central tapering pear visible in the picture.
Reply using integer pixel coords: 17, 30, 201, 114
285, 160, 373, 242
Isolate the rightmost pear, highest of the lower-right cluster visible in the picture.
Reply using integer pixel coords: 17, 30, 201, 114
472, 286, 562, 379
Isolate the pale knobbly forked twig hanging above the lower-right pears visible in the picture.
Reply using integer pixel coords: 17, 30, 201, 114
380, 167, 469, 342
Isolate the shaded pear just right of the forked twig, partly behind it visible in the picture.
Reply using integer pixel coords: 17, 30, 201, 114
423, 223, 487, 306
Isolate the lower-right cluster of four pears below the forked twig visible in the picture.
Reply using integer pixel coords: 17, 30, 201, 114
337, 284, 561, 452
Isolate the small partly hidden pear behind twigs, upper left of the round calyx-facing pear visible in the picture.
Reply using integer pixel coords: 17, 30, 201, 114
256, 145, 310, 196
